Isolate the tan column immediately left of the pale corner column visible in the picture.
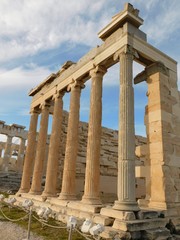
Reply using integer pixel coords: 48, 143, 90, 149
82, 66, 106, 204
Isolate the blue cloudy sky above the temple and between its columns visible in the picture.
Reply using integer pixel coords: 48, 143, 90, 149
0, 0, 180, 141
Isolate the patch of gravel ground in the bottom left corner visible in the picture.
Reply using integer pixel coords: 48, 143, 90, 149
0, 221, 43, 240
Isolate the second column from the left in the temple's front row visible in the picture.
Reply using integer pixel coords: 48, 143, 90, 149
29, 102, 50, 195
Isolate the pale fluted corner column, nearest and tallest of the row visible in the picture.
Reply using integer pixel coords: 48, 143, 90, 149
113, 46, 139, 211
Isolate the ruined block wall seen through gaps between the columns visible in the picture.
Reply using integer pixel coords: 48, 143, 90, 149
59, 112, 149, 202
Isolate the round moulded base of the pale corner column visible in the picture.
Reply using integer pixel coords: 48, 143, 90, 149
113, 201, 140, 212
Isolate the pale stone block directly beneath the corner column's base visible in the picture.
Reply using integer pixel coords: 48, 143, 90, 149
100, 207, 136, 220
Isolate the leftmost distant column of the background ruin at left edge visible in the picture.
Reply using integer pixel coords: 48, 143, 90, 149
2, 135, 13, 172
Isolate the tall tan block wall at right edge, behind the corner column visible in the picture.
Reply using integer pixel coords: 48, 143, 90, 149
145, 63, 180, 214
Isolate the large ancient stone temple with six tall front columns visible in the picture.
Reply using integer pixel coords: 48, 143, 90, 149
14, 4, 180, 239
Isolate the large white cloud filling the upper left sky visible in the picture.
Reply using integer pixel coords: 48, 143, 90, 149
0, 0, 108, 62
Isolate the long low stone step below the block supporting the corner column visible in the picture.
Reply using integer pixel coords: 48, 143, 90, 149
113, 218, 167, 232
